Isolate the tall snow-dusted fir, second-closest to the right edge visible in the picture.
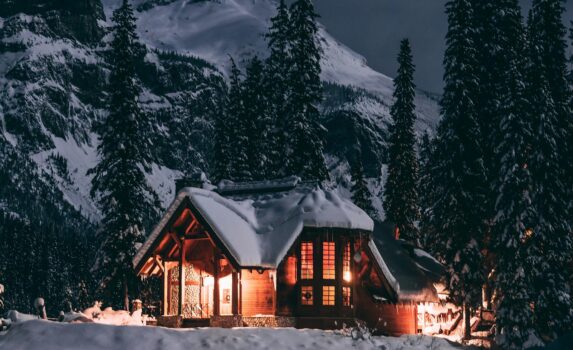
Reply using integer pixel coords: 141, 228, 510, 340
482, 0, 535, 349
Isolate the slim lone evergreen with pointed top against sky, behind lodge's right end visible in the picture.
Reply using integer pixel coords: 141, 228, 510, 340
384, 40, 420, 244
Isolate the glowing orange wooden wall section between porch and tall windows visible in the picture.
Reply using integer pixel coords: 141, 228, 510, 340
241, 270, 275, 316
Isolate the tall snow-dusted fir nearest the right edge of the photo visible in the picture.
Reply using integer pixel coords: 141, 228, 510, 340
526, 1, 573, 340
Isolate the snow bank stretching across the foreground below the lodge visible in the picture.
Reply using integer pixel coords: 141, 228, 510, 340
0, 320, 459, 350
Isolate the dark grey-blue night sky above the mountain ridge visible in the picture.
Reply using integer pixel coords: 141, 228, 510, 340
314, 0, 573, 93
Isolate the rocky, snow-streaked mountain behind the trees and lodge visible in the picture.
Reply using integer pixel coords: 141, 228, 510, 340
0, 0, 439, 230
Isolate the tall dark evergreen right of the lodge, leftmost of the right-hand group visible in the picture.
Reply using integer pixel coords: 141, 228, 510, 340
432, 0, 487, 338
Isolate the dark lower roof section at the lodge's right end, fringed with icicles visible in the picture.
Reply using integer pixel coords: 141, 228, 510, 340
369, 223, 444, 302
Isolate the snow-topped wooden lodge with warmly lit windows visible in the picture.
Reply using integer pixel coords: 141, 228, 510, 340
134, 178, 444, 335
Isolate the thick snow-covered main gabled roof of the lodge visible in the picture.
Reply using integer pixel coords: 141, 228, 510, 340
133, 179, 374, 268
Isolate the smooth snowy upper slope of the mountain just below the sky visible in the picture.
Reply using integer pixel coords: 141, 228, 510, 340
103, 0, 439, 131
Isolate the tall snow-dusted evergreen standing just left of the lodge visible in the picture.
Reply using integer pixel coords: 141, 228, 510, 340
90, 0, 158, 309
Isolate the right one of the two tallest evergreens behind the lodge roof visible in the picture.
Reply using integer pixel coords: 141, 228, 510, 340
285, 0, 328, 180
